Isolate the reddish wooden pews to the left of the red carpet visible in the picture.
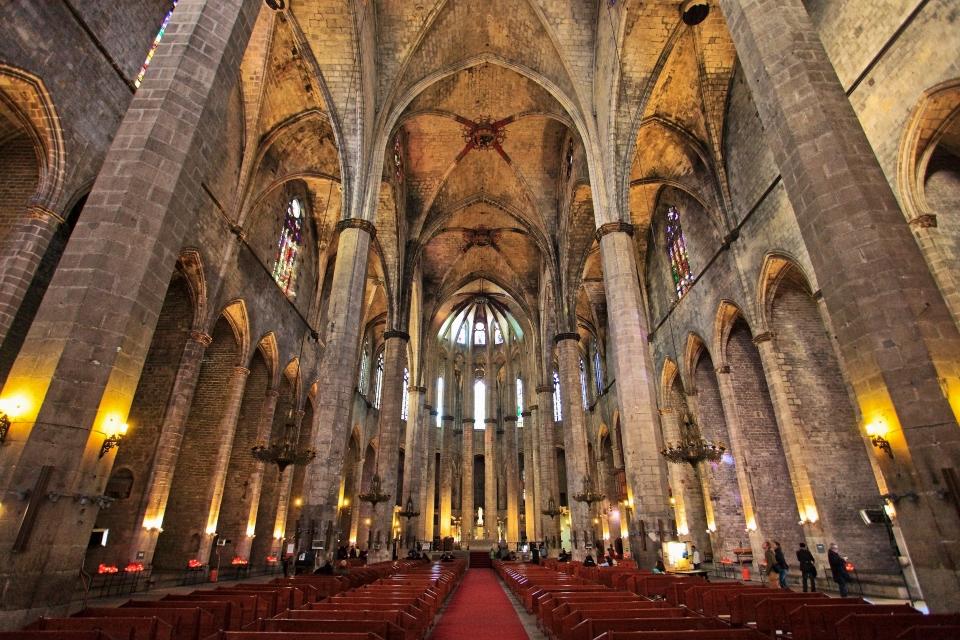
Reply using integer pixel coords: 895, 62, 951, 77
6, 561, 466, 640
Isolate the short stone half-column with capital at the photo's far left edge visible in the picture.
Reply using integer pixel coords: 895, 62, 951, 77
0, 204, 66, 344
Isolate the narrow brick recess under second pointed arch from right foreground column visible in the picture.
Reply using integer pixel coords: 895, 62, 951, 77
727, 320, 803, 549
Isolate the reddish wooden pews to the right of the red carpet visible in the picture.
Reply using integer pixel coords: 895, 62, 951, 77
494, 562, 960, 640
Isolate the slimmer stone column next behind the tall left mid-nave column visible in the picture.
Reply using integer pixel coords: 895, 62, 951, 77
369, 329, 410, 562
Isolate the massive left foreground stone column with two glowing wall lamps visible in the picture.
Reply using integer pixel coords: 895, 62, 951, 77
0, 0, 261, 629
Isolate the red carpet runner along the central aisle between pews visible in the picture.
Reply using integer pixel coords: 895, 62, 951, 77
430, 569, 527, 640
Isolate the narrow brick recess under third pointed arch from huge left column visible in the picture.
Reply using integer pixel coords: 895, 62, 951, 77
217, 349, 270, 558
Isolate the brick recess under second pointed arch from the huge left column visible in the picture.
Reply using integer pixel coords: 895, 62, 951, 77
154, 318, 238, 569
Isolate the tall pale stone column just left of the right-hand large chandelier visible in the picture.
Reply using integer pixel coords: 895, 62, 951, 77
597, 222, 670, 567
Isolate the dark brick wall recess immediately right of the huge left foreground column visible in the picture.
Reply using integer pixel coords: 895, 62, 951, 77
87, 272, 193, 567
